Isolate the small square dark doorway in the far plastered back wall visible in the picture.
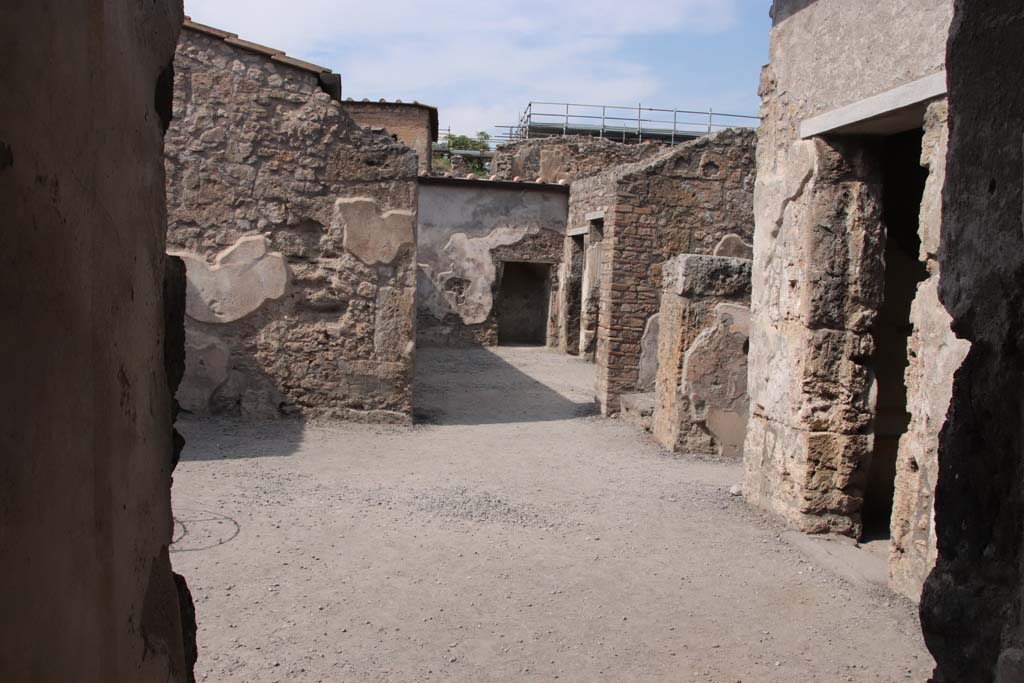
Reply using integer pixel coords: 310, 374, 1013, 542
496, 261, 551, 345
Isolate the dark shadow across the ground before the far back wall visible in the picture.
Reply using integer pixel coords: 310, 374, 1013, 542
413, 349, 598, 425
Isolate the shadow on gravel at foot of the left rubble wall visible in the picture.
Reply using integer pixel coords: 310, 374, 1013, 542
175, 416, 306, 462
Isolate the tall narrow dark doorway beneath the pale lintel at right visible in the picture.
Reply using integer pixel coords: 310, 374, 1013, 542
862, 130, 928, 540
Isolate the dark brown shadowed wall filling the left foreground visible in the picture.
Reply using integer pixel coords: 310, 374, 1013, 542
0, 0, 193, 683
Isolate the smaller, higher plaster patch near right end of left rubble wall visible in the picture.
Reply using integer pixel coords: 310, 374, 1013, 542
332, 197, 416, 265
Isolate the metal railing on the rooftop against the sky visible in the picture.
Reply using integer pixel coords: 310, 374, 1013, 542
498, 102, 760, 144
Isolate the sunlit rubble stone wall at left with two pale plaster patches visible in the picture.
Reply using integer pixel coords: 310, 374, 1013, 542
167, 30, 416, 422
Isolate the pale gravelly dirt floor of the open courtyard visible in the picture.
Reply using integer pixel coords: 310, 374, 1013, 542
172, 348, 931, 683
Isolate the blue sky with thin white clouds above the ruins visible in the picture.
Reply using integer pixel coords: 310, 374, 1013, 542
185, 0, 771, 139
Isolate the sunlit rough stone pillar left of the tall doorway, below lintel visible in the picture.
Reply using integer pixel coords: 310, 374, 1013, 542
743, 139, 883, 535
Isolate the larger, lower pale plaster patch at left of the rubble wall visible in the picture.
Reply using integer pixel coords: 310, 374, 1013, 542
167, 234, 288, 323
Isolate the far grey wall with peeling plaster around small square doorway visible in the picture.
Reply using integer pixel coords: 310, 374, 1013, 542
417, 178, 567, 346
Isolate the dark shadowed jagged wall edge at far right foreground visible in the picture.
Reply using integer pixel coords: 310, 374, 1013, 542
921, 0, 1024, 683
